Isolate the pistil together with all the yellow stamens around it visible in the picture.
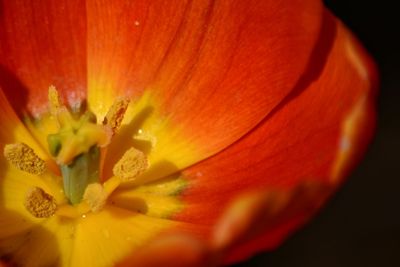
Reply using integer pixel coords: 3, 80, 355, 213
4, 86, 148, 218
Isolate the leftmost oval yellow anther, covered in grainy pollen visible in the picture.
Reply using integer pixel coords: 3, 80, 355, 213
3, 143, 46, 175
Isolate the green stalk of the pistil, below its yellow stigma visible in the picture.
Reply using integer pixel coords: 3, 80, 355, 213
60, 146, 100, 205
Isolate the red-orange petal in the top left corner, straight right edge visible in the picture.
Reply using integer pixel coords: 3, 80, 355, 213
0, 0, 86, 113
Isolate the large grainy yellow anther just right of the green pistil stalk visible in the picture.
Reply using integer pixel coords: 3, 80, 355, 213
113, 147, 149, 182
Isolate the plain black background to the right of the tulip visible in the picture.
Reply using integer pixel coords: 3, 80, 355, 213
235, 0, 400, 267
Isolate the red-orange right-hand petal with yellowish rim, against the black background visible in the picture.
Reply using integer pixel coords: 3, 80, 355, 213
176, 10, 376, 260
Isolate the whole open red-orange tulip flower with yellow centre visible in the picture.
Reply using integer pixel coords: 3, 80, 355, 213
0, 0, 376, 267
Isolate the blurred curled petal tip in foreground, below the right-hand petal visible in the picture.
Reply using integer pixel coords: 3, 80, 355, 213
213, 182, 330, 250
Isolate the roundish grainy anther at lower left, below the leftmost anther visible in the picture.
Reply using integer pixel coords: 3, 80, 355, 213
24, 187, 57, 218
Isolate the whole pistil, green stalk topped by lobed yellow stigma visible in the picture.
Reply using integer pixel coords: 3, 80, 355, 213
47, 109, 110, 205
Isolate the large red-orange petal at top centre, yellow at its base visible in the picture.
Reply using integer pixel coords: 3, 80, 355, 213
88, 1, 322, 178
